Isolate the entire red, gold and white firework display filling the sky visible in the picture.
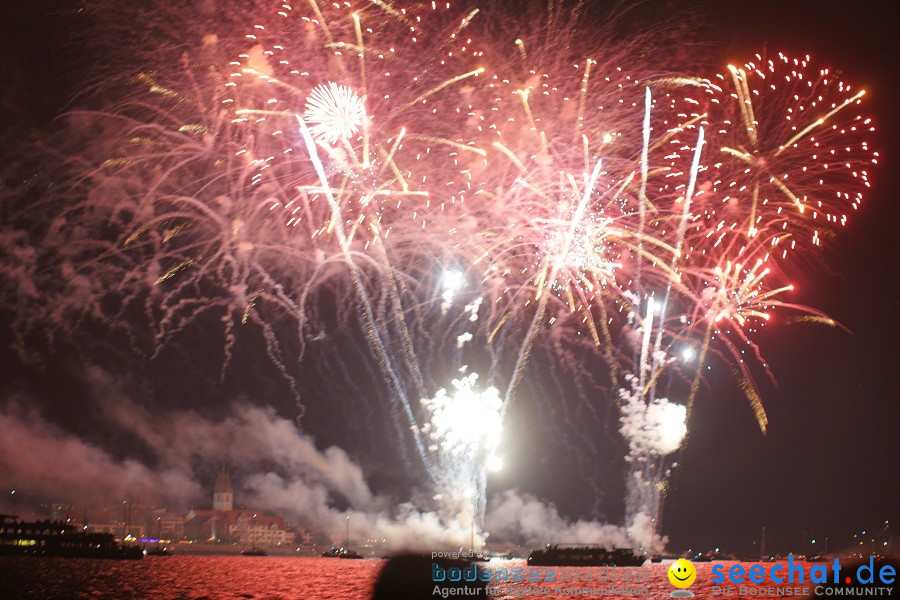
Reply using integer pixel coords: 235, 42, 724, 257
3, 0, 878, 549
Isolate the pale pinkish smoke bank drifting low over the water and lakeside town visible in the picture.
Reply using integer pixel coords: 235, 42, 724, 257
0, 367, 647, 550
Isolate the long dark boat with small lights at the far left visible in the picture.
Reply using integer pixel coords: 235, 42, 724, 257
0, 515, 144, 560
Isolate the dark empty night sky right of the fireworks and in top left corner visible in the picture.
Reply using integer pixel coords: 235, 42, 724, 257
0, 0, 900, 549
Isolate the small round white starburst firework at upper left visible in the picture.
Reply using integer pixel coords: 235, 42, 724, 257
303, 81, 366, 144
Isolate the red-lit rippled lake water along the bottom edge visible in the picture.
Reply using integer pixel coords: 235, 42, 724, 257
0, 555, 876, 600
